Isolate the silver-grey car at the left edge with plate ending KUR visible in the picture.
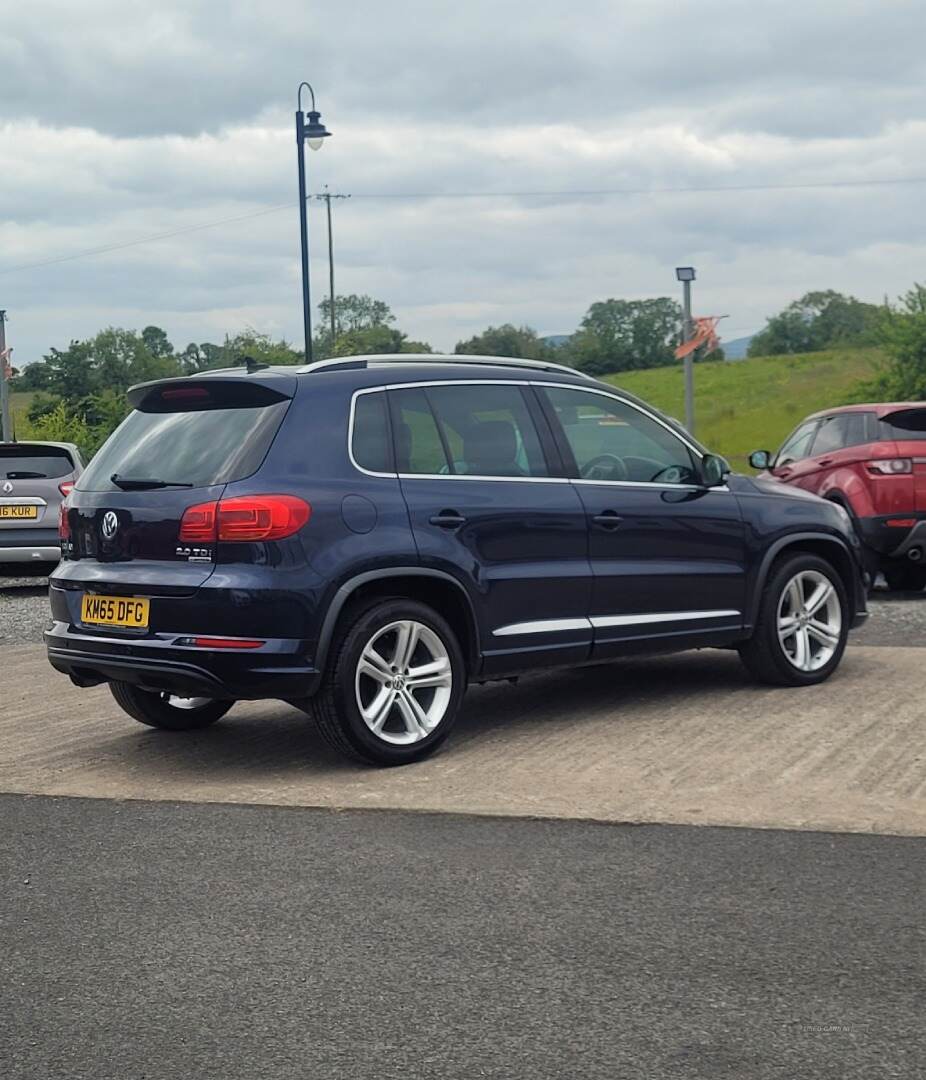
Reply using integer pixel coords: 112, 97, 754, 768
0, 443, 83, 575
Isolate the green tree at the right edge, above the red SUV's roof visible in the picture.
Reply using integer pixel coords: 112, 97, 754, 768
857, 284, 926, 402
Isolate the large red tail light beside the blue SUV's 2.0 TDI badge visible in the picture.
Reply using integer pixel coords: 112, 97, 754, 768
179, 495, 312, 543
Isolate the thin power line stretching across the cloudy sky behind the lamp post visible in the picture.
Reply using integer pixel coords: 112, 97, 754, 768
0, 176, 926, 274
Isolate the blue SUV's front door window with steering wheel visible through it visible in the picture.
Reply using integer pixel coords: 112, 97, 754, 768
546, 389, 697, 484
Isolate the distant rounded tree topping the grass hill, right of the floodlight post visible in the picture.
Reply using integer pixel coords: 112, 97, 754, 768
748, 289, 881, 356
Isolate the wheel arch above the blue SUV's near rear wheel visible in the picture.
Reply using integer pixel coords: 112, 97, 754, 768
316, 566, 482, 675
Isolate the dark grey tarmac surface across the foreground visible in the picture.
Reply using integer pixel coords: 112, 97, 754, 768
0, 796, 926, 1080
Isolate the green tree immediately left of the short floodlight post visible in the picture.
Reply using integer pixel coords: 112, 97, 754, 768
564, 296, 682, 375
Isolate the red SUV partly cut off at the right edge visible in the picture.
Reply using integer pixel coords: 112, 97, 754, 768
749, 402, 926, 589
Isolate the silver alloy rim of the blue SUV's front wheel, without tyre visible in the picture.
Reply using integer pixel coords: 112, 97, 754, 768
778, 570, 843, 672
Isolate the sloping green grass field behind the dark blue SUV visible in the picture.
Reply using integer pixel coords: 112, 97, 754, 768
605, 349, 882, 469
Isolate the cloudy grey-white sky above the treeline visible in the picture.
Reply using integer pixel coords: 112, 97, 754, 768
0, 0, 926, 363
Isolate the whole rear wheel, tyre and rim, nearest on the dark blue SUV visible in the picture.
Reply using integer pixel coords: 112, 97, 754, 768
311, 599, 466, 765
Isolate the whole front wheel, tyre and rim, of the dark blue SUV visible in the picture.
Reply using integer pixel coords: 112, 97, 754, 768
739, 554, 849, 686
